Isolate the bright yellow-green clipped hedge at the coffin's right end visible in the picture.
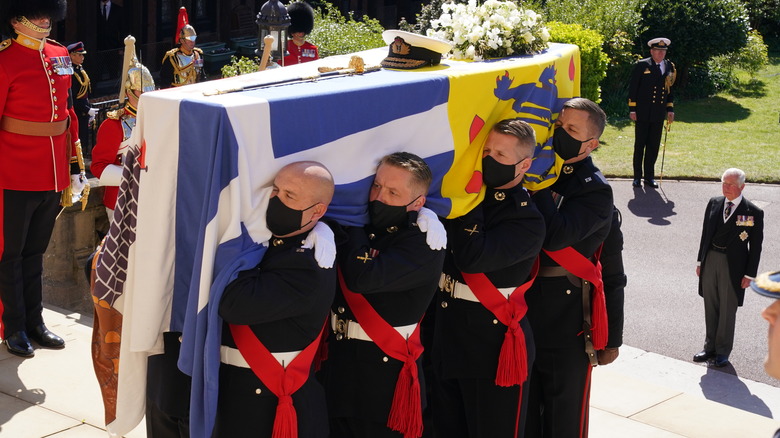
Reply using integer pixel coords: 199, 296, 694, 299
547, 21, 609, 103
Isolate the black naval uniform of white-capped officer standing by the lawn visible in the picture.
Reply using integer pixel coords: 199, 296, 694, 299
628, 58, 674, 180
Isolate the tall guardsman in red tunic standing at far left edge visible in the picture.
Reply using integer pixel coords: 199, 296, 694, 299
0, 0, 83, 357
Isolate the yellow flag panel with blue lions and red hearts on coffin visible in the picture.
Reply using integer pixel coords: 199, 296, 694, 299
431, 44, 580, 218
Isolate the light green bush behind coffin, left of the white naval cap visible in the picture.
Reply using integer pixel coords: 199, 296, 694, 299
306, 3, 385, 58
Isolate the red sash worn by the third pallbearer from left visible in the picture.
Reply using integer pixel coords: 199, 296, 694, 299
461, 257, 539, 386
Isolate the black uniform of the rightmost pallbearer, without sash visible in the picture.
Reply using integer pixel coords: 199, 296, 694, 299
525, 157, 613, 438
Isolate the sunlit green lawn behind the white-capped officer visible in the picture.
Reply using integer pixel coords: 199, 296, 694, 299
594, 53, 780, 183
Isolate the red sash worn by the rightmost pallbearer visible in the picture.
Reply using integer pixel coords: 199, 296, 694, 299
544, 245, 609, 350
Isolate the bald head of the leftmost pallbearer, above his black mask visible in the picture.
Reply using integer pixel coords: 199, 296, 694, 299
269, 161, 334, 237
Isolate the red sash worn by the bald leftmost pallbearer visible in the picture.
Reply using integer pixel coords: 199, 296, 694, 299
230, 324, 325, 438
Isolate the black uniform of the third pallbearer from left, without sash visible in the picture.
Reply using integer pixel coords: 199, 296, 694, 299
432, 185, 545, 438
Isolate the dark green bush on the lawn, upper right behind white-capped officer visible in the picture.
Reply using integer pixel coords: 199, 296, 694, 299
641, 0, 749, 88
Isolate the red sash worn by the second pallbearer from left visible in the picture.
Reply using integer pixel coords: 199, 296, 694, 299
338, 269, 423, 438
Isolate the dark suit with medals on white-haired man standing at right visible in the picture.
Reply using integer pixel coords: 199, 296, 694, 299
697, 196, 764, 356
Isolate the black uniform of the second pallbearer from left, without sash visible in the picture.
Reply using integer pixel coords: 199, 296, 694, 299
322, 212, 444, 438
